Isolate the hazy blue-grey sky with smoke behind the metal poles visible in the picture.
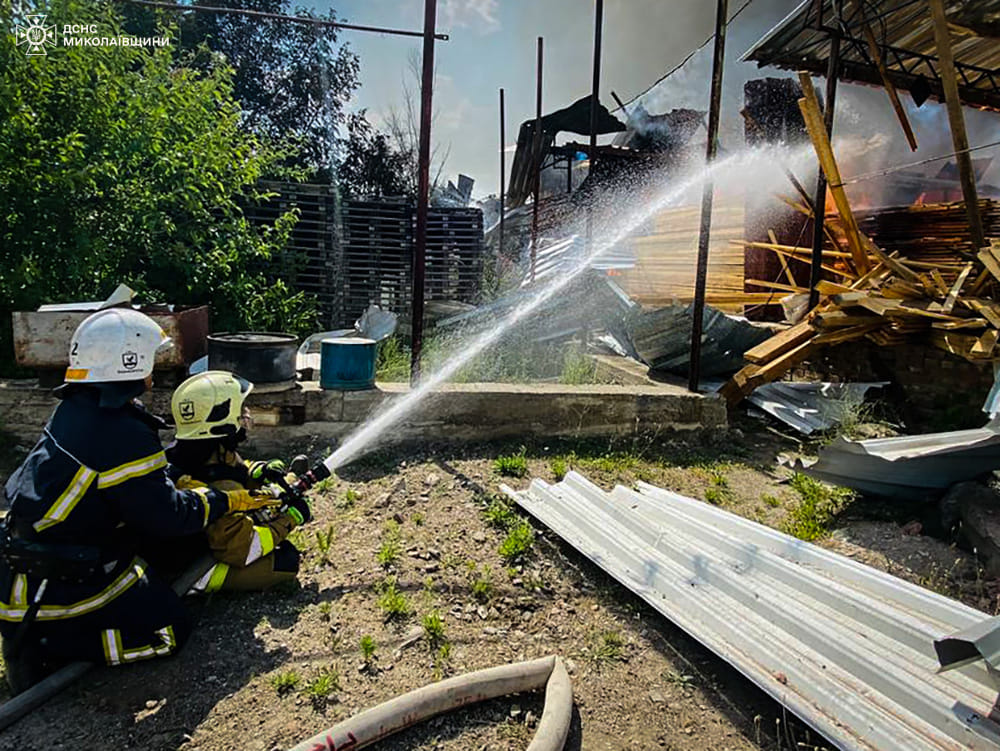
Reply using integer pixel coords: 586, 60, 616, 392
315, 0, 1000, 197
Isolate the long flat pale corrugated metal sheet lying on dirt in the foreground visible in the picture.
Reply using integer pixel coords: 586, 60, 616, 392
502, 472, 1000, 751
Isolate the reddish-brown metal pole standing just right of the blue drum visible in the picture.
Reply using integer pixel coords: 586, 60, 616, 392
410, 0, 437, 385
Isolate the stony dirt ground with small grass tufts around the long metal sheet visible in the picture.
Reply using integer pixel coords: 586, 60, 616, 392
0, 421, 997, 751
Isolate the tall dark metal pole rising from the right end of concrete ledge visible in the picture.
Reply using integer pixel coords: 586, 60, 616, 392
688, 0, 729, 391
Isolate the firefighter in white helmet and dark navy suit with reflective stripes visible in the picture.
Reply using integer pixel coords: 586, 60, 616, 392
0, 308, 273, 693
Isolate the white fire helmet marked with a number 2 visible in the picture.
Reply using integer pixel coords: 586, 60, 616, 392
66, 308, 170, 383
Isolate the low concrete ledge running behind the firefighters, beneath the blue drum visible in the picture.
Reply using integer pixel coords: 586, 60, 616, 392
0, 381, 727, 452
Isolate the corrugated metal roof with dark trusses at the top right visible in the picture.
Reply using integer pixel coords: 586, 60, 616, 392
743, 0, 1000, 109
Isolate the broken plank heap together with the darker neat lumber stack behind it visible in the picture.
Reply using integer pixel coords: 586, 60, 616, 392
722, 201, 1000, 405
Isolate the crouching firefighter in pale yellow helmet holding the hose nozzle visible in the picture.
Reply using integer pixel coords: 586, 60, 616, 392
166, 370, 311, 592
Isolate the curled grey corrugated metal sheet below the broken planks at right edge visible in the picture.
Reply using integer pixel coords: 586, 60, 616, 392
796, 423, 1000, 499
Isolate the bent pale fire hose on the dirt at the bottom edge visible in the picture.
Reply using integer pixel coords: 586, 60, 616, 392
291, 657, 573, 751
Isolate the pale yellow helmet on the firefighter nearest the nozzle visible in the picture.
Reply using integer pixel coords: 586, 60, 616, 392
170, 370, 253, 441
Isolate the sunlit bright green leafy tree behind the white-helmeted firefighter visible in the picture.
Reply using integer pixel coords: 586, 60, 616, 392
0, 0, 310, 370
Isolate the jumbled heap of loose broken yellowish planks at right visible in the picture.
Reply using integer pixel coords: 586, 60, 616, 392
722, 232, 1000, 412
